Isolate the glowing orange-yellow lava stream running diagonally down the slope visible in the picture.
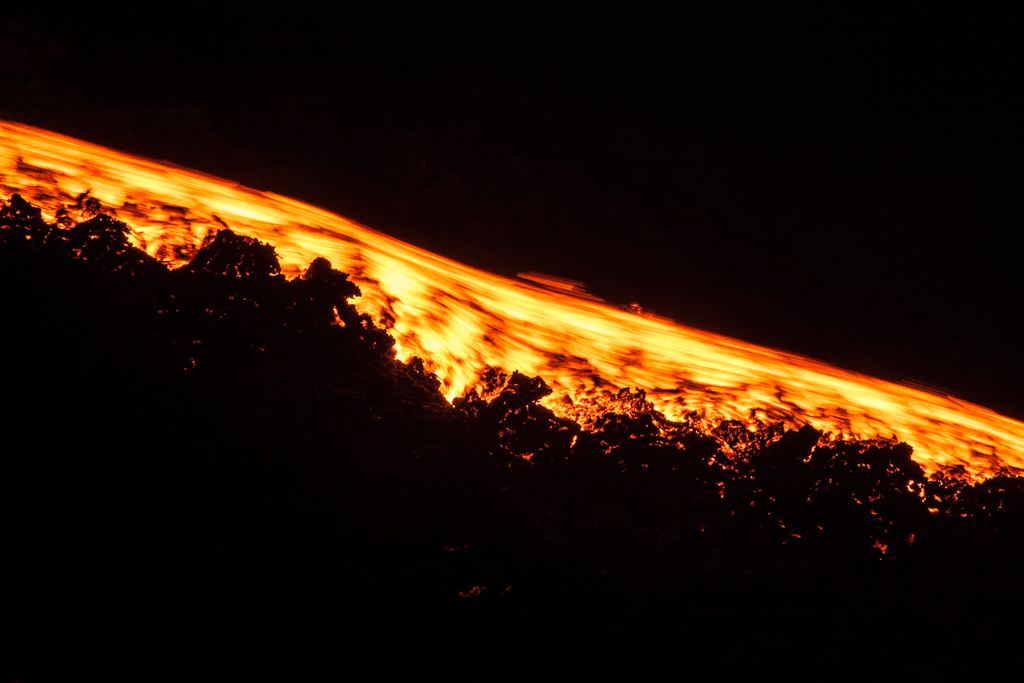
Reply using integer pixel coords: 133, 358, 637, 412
0, 122, 1024, 477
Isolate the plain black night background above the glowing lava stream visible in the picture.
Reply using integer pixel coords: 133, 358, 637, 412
0, 3, 1024, 419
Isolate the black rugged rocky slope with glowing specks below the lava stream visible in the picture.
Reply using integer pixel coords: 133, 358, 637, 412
0, 197, 1024, 681
